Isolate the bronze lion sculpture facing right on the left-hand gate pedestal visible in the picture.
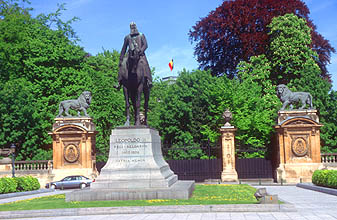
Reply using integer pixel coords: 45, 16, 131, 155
57, 91, 91, 117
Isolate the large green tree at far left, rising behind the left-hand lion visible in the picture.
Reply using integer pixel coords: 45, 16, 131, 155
0, 0, 90, 159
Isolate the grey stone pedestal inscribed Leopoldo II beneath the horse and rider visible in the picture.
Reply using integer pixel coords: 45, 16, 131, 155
66, 127, 194, 201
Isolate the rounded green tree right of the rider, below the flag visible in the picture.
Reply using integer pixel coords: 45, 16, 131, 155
156, 70, 230, 159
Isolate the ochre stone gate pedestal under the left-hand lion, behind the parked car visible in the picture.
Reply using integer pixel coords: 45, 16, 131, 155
49, 117, 98, 180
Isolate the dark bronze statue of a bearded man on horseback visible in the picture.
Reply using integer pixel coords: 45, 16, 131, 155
116, 22, 152, 126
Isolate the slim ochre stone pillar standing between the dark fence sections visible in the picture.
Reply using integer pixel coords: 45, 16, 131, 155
220, 126, 238, 182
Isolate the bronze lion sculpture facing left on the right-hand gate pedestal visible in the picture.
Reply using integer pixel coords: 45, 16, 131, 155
276, 84, 313, 110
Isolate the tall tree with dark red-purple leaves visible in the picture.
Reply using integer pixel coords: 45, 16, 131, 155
189, 0, 335, 78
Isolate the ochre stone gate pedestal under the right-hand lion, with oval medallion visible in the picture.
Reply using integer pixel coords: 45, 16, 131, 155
275, 110, 323, 183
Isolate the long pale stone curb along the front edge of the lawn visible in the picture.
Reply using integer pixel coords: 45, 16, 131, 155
0, 203, 297, 219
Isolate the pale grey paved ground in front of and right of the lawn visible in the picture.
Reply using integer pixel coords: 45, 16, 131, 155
5, 186, 337, 220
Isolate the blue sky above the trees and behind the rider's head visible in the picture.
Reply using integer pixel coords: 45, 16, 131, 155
26, 0, 337, 90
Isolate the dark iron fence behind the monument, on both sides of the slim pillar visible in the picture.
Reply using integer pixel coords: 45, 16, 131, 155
96, 142, 273, 182
